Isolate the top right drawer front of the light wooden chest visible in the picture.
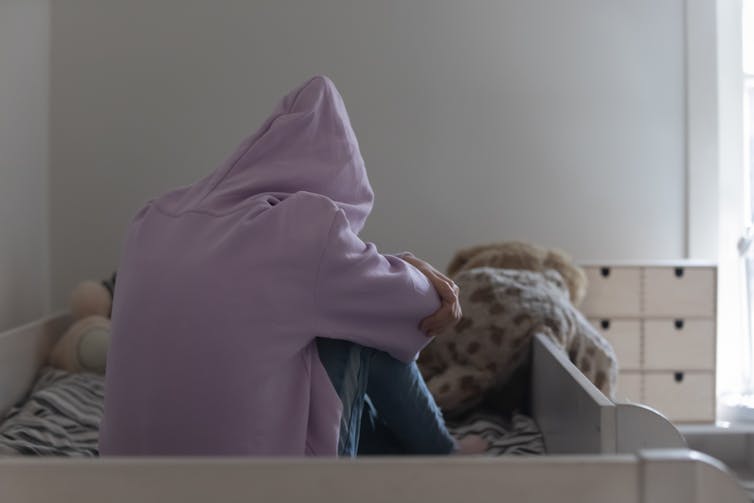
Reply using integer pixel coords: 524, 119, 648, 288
642, 267, 715, 317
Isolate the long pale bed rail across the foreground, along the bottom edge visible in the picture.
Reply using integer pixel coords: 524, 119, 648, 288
0, 449, 748, 503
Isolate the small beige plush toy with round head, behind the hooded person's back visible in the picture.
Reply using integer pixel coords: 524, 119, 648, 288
48, 274, 115, 374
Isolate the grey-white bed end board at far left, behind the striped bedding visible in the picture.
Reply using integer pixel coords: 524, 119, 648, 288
0, 313, 71, 417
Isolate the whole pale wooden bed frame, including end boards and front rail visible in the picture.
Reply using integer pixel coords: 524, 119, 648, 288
0, 314, 748, 503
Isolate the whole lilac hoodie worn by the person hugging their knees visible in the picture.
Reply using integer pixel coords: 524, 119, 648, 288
100, 77, 440, 456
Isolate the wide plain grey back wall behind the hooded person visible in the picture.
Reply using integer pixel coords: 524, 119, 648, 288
50, 0, 686, 310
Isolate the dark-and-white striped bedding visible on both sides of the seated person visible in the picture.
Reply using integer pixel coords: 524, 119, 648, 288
0, 367, 545, 457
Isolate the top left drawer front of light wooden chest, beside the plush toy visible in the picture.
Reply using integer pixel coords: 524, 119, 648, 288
581, 267, 641, 317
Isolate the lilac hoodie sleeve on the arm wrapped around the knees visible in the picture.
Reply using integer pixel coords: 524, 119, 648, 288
314, 210, 440, 363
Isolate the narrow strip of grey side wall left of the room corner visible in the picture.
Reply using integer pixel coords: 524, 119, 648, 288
0, 0, 50, 330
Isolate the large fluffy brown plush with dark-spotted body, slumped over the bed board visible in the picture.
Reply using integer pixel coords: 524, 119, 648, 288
418, 242, 617, 416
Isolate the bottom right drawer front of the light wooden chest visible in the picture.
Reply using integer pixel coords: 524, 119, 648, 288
644, 372, 715, 422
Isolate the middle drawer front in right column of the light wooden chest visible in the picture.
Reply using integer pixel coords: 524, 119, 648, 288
644, 318, 715, 370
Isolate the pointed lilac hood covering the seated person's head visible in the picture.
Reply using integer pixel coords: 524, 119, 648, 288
168, 76, 374, 233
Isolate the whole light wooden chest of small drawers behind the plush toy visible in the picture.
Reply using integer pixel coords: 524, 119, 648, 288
581, 261, 717, 422
